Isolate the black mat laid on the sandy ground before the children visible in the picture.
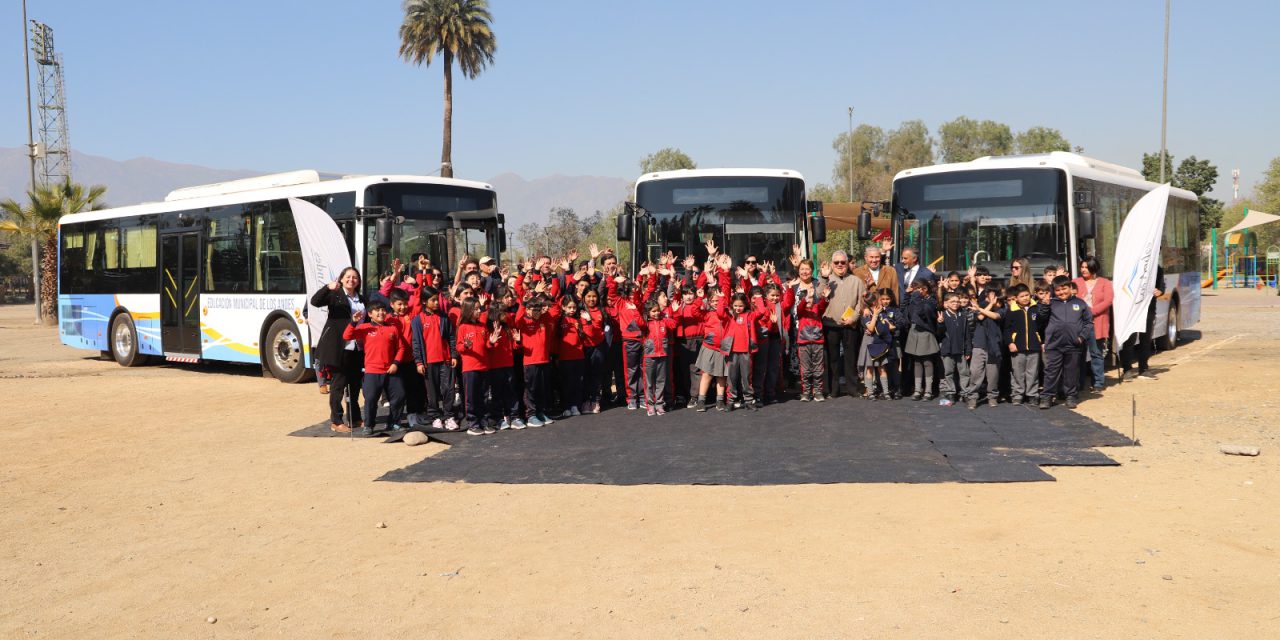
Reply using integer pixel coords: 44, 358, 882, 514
366, 398, 1129, 485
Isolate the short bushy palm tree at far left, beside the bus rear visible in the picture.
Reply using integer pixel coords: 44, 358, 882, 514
0, 178, 106, 324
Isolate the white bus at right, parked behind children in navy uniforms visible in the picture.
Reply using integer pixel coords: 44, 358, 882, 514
891, 151, 1201, 349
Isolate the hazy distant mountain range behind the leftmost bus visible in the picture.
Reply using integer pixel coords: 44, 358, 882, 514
0, 147, 630, 230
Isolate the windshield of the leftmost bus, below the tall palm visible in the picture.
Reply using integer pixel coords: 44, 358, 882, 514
365, 183, 498, 289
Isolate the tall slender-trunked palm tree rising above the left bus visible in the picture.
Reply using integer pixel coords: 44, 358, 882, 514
399, 0, 498, 178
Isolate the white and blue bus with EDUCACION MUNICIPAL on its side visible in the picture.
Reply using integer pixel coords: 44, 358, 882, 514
58, 170, 506, 383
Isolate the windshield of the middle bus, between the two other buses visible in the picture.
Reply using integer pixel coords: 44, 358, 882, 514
636, 175, 804, 264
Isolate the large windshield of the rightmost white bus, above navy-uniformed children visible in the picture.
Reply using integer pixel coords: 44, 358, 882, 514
893, 169, 1068, 279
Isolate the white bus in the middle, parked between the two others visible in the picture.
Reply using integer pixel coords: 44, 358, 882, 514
618, 169, 826, 266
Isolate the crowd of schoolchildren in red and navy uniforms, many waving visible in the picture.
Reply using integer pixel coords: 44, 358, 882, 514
327, 243, 1111, 435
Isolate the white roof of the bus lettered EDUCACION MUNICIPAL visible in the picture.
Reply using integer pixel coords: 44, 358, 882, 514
58, 170, 493, 224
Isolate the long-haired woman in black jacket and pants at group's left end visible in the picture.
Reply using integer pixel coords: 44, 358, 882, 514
311, 266, 369, 433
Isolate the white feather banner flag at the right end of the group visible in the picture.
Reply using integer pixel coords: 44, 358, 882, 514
1111, 184, 1169, 347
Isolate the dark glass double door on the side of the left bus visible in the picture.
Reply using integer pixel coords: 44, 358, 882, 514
160, 232, 200, 357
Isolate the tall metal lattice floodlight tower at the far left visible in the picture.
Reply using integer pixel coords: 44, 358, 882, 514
31, 20, 72, 184
